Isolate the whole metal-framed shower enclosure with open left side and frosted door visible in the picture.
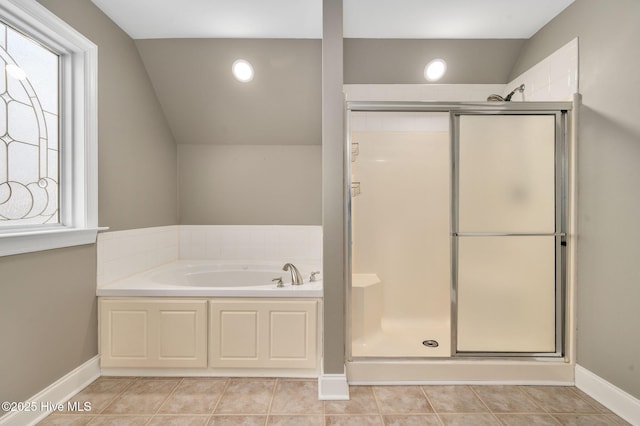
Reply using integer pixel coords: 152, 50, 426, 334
346, 102, 571, 361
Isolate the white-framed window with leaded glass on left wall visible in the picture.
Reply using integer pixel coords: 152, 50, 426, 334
0, 0, 97, 256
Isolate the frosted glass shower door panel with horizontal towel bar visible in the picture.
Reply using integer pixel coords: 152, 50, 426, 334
452, 113, 564, 355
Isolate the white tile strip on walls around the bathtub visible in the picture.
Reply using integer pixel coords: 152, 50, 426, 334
97, 225, 322, 287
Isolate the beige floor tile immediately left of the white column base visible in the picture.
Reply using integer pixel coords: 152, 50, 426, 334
271, 380, 324, 414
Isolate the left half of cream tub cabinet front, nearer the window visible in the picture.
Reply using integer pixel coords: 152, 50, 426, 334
99, 298, 207, 368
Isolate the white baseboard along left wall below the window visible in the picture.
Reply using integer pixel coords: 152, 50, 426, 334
0, 355, 100, 426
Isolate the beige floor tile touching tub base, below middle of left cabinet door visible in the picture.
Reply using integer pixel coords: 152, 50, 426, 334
103, 378, 180, 414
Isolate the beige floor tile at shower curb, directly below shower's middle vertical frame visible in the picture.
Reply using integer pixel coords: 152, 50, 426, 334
422, 386, 489, 413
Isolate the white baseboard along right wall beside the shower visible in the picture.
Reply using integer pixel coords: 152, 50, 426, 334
576, 365, 640, 426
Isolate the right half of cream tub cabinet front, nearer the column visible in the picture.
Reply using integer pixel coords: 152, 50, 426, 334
209, 299, 318, 369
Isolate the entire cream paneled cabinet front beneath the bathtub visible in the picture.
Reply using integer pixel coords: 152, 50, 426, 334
99, 297, 319, 374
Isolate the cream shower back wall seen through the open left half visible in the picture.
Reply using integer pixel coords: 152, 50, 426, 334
351, 131, 450, 323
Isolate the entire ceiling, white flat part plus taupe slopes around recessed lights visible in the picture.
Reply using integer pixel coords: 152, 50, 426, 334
112, 0, 571, 145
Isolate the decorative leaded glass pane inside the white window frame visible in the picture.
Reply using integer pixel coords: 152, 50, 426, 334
0, 22, 60, 226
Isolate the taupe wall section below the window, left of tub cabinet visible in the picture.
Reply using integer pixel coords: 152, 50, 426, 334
0, 245, 98, 404
